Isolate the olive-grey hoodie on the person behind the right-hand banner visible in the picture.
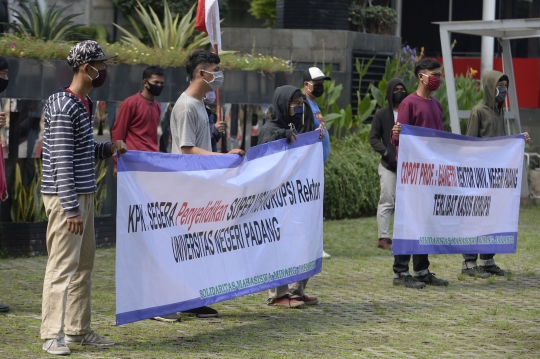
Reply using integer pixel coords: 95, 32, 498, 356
467, 70, 508, 137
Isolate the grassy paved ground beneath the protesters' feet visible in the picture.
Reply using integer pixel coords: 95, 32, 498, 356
0, 207, 540, 358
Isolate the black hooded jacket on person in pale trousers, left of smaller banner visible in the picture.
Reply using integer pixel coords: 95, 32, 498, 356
369, 78, 407, 172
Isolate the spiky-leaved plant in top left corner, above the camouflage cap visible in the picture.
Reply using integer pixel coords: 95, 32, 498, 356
3, 0, 88, 40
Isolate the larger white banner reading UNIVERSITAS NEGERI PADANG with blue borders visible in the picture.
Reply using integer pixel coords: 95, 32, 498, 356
116, 131, 324, 325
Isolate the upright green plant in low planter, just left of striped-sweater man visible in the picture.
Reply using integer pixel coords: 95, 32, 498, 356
11, 159, 47, 223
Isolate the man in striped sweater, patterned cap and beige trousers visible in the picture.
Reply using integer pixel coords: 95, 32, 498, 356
41, 40, 127, 355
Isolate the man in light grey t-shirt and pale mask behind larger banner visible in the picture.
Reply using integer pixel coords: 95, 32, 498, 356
154, 50, 245, 322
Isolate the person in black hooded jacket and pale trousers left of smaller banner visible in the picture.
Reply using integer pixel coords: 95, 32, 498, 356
369, 78, 407, 249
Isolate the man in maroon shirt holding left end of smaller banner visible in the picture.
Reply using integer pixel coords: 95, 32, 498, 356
390, 59, 448, 288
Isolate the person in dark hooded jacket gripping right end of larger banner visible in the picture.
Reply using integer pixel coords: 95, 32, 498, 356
257, 85, 325, 307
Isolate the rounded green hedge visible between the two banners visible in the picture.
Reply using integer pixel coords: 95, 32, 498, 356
324, 134, 380, 219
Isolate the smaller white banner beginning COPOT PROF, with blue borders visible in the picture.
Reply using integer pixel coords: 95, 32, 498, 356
392, 126, 525, 254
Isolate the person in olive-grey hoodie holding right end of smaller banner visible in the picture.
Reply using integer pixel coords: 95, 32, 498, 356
461, 70, 530, 278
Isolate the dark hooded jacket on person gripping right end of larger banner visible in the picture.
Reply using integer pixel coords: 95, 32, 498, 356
257, 85, 314, 145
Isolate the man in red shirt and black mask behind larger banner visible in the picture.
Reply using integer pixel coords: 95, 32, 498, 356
112, 66, 165, 175
